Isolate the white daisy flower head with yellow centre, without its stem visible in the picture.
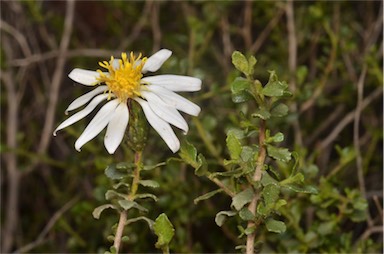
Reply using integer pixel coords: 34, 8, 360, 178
53, 49, 201, 154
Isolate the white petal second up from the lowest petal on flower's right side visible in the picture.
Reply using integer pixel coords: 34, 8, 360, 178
141, 91, 188, 134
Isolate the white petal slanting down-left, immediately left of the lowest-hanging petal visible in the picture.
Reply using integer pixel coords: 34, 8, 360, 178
75, 99, 119, 151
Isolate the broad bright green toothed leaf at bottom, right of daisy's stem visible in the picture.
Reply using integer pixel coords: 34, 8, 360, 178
153, 213, 175, 251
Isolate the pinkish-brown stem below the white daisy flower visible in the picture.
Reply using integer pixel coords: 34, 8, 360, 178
113, 151, 142, 254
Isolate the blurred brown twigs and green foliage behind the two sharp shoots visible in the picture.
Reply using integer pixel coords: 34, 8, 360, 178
0, 1, 383, 253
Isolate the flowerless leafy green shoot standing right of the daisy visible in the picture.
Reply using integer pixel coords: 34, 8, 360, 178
180, 51, 317, 254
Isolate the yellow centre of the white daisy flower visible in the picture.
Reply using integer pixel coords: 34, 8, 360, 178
97, 52, 147, 101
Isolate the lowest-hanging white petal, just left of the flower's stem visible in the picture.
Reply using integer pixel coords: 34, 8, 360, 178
104, 103, 129, 154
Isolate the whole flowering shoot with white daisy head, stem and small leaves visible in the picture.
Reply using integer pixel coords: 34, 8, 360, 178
54, 49, 201, 253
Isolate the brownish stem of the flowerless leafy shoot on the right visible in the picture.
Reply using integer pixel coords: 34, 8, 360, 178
246, 120, 267, 254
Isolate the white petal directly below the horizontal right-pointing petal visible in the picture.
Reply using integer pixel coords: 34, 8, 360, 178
145, 85, 201, 116
